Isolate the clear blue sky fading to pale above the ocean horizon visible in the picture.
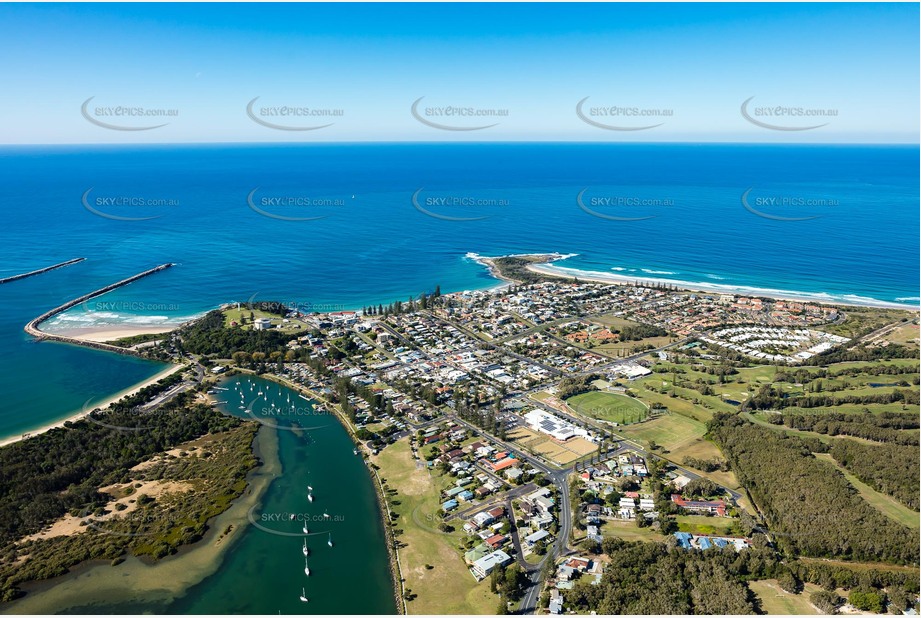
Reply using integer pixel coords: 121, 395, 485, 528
0, 3, 919, 144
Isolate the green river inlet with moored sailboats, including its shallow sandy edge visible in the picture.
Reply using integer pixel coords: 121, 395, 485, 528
3, 376, 396, 614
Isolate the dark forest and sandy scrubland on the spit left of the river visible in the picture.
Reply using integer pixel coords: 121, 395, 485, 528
0, 396, 258, 601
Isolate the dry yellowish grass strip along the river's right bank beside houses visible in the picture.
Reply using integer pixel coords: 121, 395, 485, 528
372, 439, 499, 614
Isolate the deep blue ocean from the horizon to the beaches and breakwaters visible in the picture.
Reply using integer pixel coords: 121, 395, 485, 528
0, 144, 919, 436
